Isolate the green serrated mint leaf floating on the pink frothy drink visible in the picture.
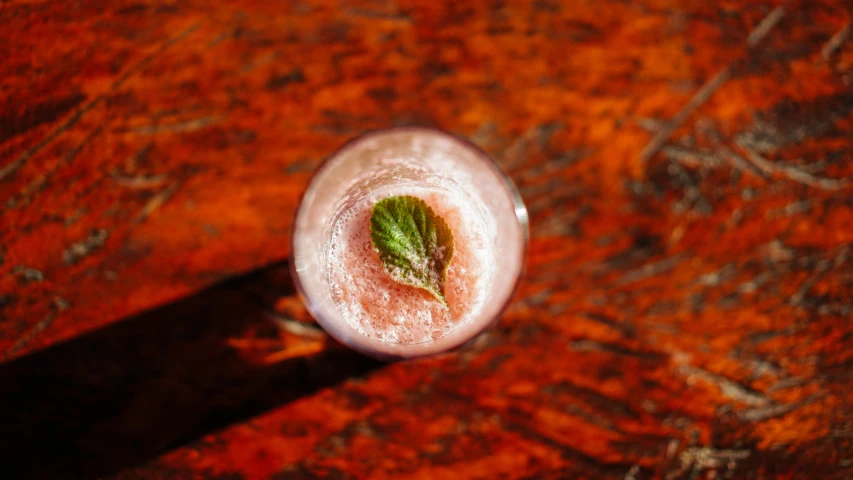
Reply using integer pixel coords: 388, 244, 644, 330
370, 195, 453, 307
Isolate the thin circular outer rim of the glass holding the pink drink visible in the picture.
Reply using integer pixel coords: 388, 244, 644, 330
288, 126, 530, 360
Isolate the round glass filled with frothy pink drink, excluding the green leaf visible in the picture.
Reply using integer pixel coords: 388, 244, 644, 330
292, 128, 527, 358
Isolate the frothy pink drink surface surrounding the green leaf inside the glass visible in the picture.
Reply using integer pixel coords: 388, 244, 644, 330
326, 179, 496, 343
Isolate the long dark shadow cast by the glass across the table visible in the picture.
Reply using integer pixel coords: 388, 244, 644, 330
0, 264, 380, 479
